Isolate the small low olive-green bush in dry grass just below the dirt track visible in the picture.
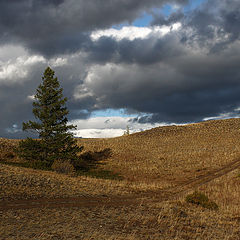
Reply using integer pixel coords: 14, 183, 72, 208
186, 192, 218, 210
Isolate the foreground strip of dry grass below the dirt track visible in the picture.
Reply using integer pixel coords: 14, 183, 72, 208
0, 202, 240, 240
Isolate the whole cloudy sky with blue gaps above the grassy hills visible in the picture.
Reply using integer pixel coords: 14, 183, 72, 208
0, 0, 240, 138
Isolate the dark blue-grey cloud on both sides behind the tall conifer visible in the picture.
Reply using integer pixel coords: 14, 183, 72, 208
0, 60, 90, 138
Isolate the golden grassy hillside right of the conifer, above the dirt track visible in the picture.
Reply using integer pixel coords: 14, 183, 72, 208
79, 119, 240, 188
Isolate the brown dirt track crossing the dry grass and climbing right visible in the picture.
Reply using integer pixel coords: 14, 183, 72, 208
0, 159, 240, 211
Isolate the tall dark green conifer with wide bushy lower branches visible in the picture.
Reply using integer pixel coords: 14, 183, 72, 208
18, 67, 82, 166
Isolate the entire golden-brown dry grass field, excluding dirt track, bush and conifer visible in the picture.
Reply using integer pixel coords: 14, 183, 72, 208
0, 119, 240, 240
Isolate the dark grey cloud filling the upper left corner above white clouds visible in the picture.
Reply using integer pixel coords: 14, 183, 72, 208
0, 0, 187, 56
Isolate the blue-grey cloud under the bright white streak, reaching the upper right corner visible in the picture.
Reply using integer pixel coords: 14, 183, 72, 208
83, 0, 240, 64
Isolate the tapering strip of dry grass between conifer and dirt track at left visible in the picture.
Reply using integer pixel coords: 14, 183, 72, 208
0, 165, 138, 200
